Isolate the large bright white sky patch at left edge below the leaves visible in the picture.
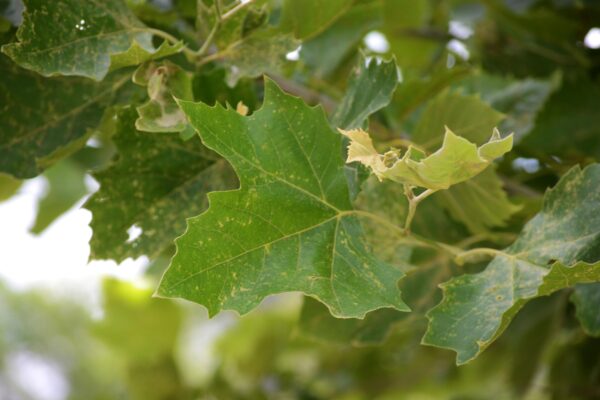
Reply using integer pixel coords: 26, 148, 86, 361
0, 177, 148, 315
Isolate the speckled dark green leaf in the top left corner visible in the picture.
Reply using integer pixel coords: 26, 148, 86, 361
2, 0, 182, 81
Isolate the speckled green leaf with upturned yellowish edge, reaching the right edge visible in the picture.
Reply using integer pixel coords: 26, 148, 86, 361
423, 164, 600, 364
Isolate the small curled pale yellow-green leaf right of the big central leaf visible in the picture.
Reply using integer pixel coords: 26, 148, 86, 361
340, 128, 512, 190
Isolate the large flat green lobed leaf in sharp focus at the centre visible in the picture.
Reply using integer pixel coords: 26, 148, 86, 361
157, 79, 407, 317
